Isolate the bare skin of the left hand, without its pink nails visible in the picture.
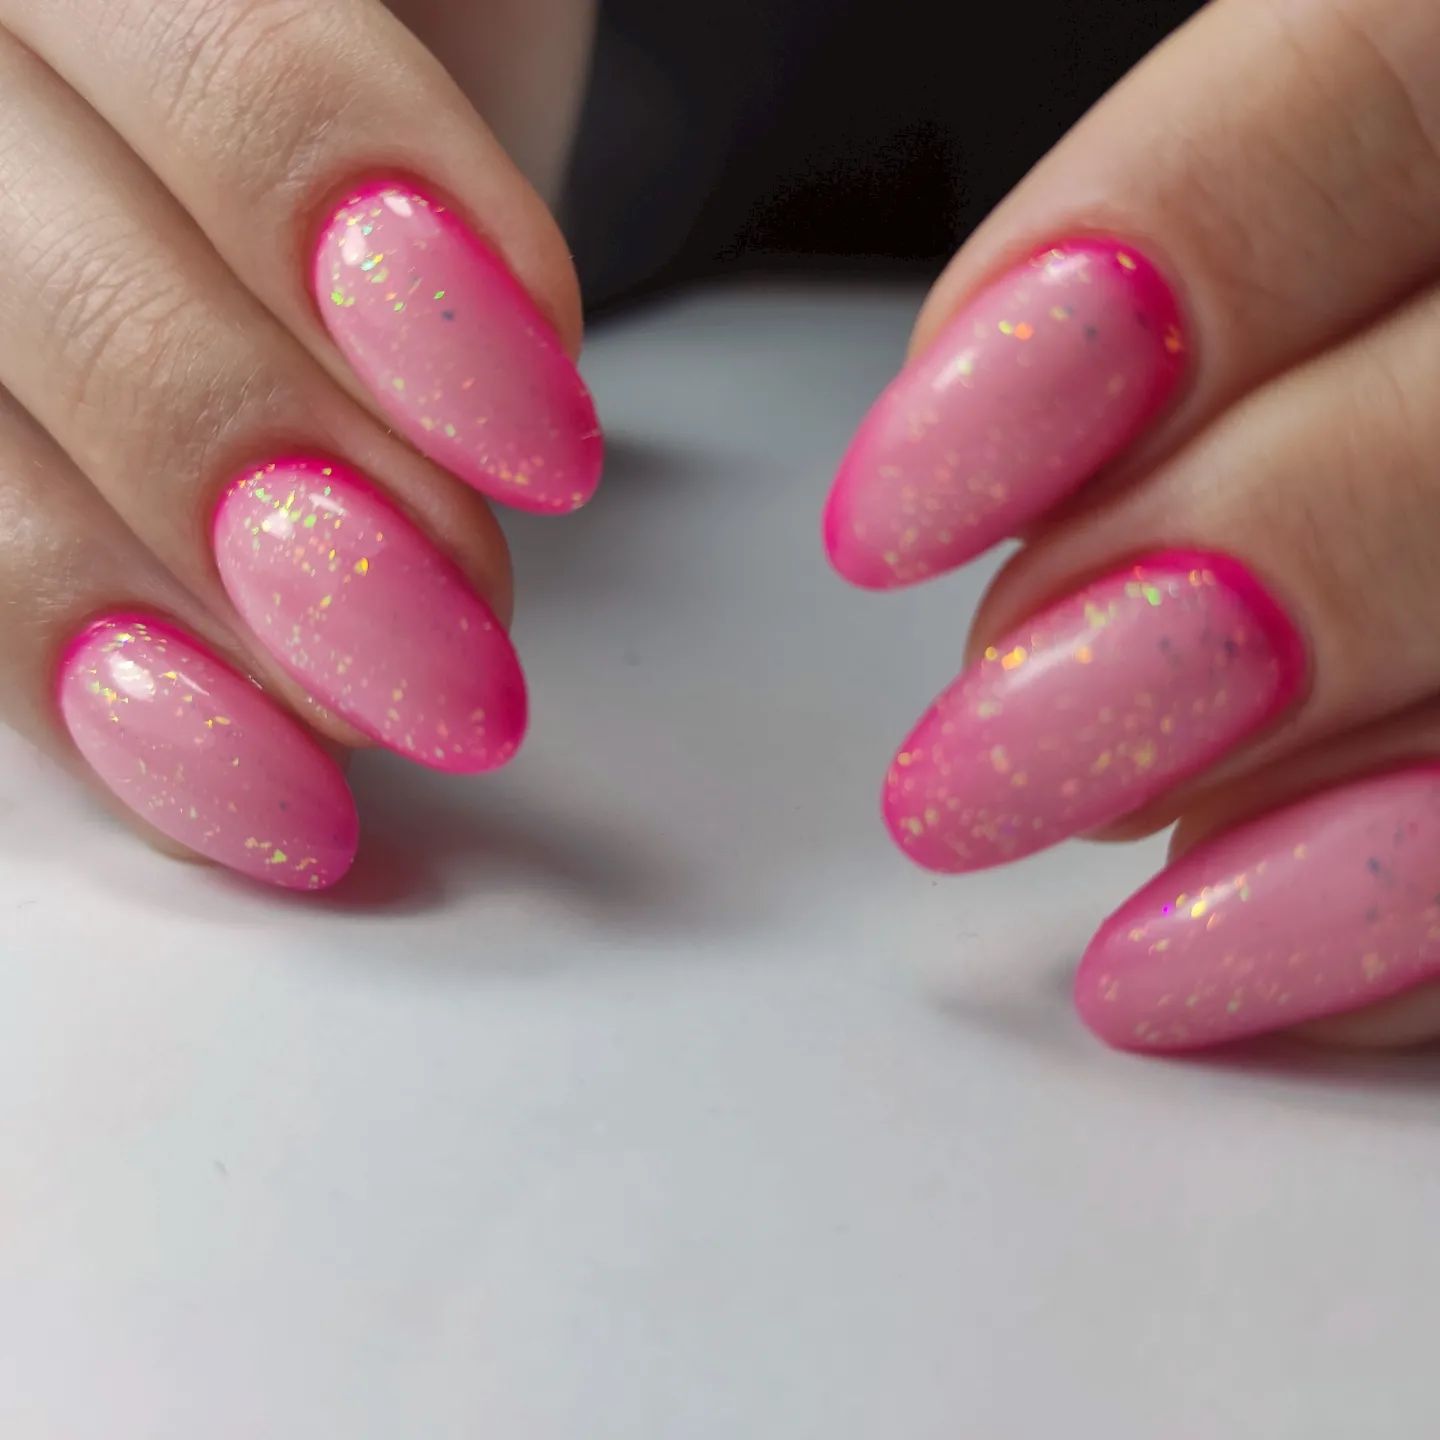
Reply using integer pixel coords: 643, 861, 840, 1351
0, 0, 593, 777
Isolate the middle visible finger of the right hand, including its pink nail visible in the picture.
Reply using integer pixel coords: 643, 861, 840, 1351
891, 264, 1440, 868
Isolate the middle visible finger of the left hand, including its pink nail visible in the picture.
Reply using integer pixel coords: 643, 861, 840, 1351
0, 36, 526, 772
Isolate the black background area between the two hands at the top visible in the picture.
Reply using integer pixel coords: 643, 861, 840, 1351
563, 0, 1200, 308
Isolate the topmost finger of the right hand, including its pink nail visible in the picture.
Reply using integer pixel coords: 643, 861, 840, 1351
827, 0, 1440, 588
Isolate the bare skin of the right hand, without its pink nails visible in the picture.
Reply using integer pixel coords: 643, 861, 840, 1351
835, 0, 1440, 1045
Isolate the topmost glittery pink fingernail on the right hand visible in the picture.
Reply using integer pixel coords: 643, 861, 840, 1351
825, 239, 1185, 589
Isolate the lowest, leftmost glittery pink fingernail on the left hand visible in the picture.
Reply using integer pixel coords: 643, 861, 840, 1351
58, 616, 359, 890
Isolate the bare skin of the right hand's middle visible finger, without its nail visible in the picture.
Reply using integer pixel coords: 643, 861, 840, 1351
978, 253, 1440, 828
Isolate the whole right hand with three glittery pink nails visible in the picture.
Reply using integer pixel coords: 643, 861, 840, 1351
825, 0, 1440, 1050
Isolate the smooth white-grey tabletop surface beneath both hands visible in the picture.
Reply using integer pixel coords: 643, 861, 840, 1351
0, 287, 1440, 1440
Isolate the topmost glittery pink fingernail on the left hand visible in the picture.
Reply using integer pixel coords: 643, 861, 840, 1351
314, 181, 603, 514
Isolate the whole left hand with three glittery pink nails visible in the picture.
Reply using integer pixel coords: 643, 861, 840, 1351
0, 0, 600, 890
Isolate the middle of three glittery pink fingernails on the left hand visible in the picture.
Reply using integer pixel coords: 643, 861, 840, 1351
215, 458, 526, 773
